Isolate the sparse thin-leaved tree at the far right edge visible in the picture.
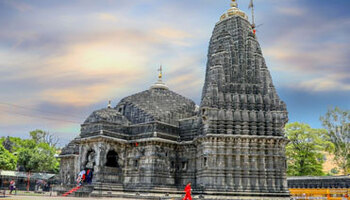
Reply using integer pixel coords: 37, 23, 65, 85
320, 107, 350, 175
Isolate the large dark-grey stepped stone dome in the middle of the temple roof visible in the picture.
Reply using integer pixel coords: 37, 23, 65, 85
115, 86, 196, 125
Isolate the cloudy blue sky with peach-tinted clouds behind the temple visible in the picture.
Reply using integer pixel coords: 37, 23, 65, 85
0, 0, 350, 145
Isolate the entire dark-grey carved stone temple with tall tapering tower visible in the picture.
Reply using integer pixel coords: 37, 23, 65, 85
60, 1, 289, 199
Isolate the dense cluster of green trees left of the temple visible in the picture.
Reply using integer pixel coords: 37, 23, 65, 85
0, 130, 59, 173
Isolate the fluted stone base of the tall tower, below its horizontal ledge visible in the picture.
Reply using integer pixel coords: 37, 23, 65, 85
195, 134, 288, 195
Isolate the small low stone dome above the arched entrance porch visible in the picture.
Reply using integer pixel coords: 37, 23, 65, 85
84, 108, 129, 124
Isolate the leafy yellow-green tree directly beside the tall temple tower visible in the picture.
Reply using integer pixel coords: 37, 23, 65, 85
285, 122, 333, 176
